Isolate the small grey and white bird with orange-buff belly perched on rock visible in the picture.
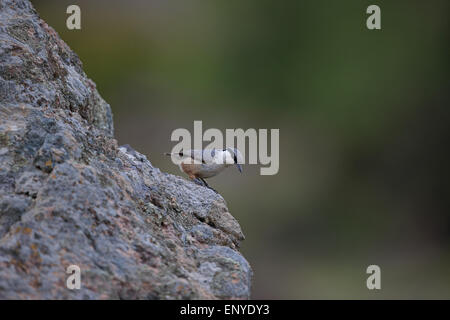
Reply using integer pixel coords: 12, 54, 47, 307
165, 148, 243, 192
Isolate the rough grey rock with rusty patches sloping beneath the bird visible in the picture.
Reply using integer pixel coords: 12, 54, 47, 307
0, 0, 252, 299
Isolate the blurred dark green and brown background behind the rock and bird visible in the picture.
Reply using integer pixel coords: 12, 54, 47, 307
32, 0, 450, 299
